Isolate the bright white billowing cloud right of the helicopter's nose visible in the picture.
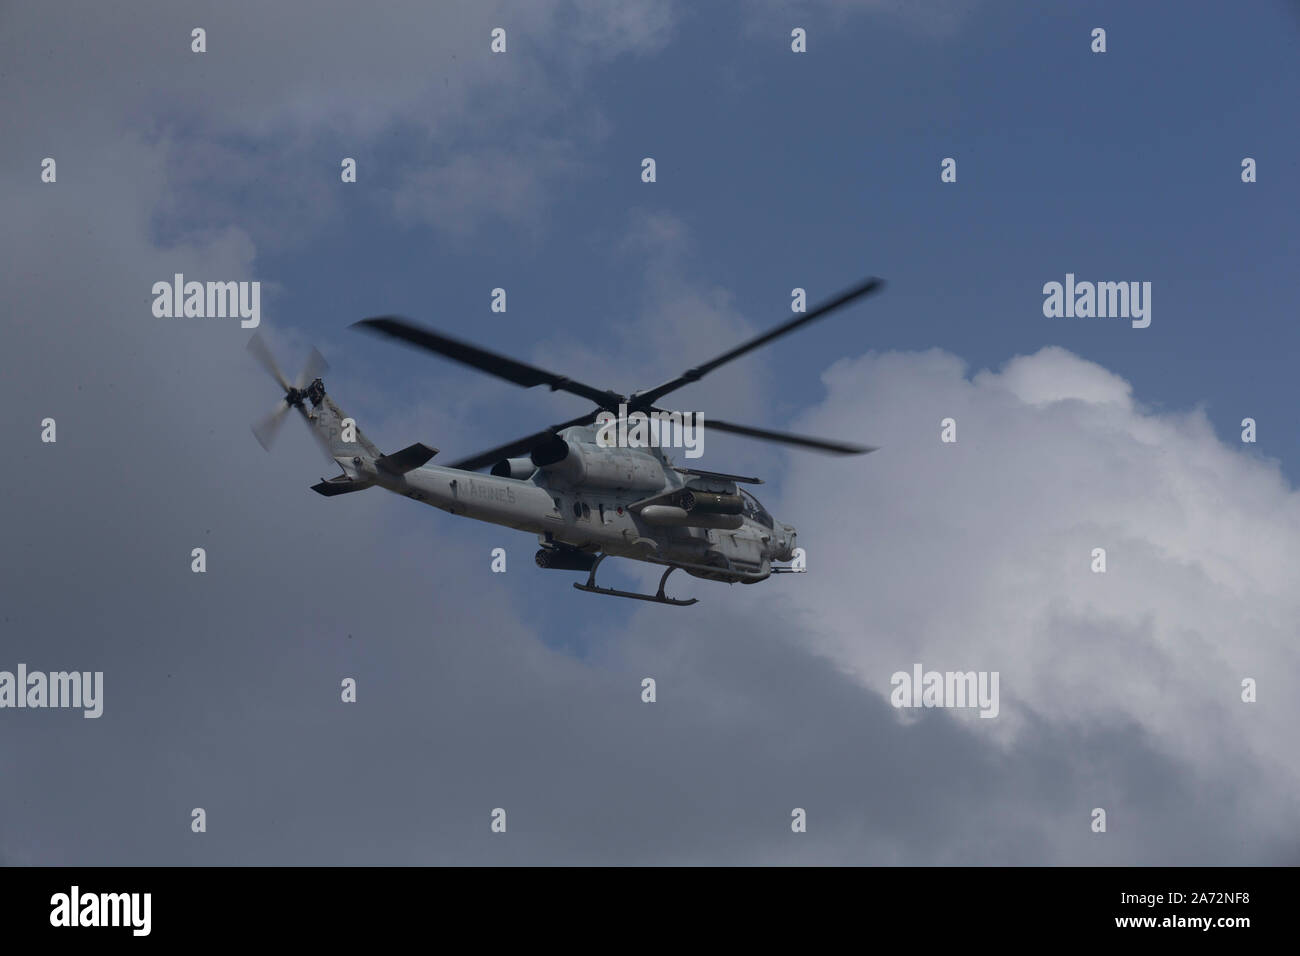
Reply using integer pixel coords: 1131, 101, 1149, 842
783, 347, 1300, 821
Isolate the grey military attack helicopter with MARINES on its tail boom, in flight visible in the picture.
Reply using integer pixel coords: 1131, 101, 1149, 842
248, 278, 884, 606
